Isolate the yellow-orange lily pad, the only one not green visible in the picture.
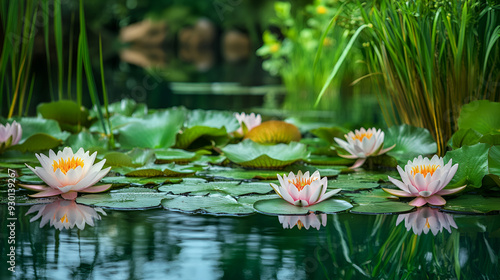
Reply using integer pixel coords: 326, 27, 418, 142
245, 120, 301, 144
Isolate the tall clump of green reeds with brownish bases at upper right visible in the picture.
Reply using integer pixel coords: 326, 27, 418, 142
362, 0, 500, 155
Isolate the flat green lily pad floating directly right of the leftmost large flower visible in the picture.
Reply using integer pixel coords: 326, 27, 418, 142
76, 187, 166, 210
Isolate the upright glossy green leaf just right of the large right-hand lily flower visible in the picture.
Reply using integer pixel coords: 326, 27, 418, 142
444, 143, 489, 188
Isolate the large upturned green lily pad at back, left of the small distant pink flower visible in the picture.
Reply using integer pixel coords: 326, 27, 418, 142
118, 108, 185, 149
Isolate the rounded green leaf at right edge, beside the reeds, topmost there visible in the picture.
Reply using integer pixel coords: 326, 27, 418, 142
457, 100, 500, 134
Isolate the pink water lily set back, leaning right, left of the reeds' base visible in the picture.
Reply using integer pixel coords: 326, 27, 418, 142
334, 127, 396, 168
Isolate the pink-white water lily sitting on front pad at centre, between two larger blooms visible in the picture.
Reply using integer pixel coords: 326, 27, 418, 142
271, 170, 340, 207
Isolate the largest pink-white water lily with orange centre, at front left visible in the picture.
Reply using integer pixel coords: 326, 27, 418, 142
21, 147, 111, 200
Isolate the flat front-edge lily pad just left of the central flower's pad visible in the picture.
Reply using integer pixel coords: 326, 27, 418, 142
161, 195, 254, 216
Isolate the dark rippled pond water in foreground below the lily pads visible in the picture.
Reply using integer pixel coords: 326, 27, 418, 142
0, 206, 500, 279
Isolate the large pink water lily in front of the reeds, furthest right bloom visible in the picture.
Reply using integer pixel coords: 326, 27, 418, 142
383, 155, 465, 207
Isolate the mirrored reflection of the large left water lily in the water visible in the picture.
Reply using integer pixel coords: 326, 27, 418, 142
26, 198, 106, 230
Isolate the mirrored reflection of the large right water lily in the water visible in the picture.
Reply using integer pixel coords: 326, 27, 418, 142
396, 207, 458, 235
